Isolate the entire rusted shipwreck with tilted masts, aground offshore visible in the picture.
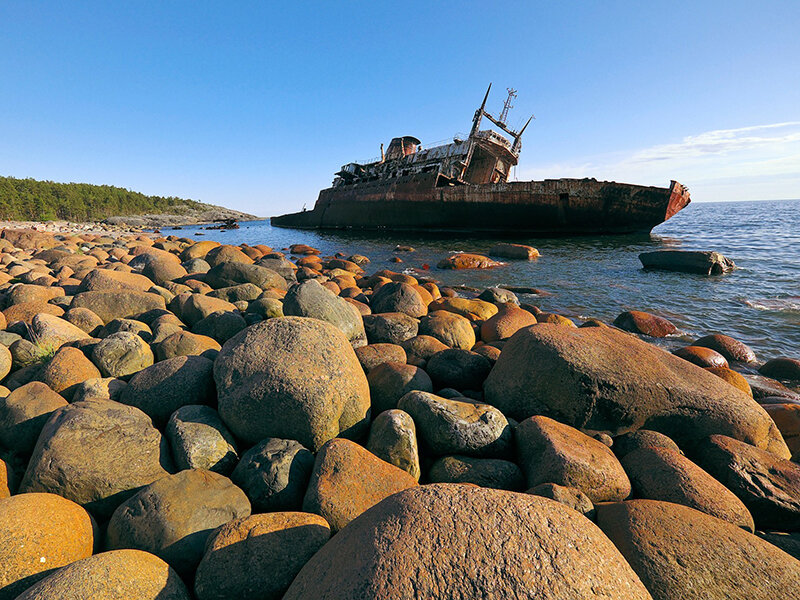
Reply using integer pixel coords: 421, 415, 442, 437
272, 84, 690, 236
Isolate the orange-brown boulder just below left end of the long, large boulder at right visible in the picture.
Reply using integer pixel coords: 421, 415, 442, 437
515, 416, 631, 503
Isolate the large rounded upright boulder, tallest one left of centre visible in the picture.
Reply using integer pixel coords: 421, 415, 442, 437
214, 317, 370, 451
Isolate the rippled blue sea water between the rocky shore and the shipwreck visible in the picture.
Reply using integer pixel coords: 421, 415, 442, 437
163, 200, 800, 360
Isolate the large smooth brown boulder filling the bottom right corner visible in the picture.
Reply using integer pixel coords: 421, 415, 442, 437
597, 500, 800, 600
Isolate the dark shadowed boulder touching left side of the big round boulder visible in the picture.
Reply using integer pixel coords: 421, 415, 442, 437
120, 356, 215, 426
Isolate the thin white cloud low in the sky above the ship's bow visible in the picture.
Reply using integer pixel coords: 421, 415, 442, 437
518, 121, 800, 201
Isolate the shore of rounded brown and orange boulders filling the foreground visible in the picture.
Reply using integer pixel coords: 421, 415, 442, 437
0, 225, 800, 600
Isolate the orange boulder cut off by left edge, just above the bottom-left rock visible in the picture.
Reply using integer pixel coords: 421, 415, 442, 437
0, 494, 98, 600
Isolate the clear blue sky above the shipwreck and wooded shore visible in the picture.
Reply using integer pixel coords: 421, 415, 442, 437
0, 0, 800, 216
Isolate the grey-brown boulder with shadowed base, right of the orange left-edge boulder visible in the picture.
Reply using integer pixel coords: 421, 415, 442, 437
106, 469, 250, 575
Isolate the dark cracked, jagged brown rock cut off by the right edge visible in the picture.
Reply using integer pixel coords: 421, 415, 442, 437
697, 435, 800, 531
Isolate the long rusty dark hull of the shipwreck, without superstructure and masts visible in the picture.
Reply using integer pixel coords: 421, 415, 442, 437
272, 176, 690, 236
